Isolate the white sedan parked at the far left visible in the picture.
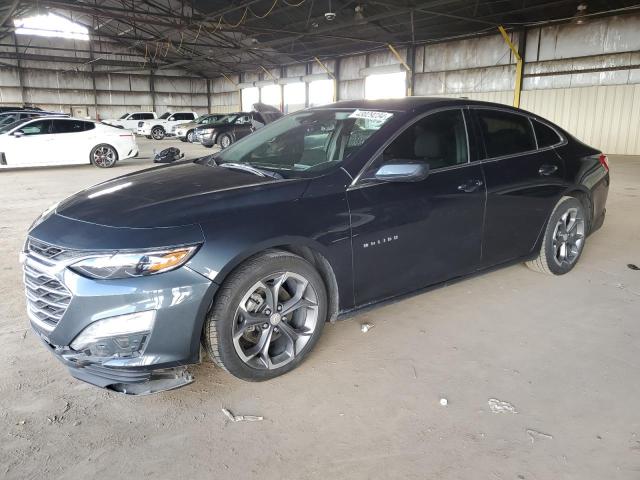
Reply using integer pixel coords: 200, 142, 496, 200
0, 117, 138, 169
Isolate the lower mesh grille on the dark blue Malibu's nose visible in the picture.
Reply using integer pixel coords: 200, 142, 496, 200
24, 262, 71, 327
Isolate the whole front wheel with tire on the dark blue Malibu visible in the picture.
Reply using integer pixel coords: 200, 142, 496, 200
203, 250, 327, 381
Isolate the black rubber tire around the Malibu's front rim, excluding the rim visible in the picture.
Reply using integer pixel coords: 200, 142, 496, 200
205, 254, 328, 381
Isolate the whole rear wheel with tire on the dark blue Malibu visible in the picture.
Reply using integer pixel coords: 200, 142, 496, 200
526, 197, 587, 275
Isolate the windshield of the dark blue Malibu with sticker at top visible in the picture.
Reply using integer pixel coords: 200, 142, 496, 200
208, 109, 393, 177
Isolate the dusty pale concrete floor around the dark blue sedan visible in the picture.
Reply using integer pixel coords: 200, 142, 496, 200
0, 139, 640, 480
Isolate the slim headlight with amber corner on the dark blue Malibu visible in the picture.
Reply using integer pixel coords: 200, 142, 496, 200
69, 246, 198, 280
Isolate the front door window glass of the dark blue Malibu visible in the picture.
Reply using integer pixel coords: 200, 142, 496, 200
382, 110, 469, 170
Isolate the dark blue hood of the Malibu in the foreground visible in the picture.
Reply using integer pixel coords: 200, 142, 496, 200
56, 161, 307, 228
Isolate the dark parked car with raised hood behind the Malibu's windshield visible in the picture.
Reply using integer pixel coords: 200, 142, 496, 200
196, 103, 282, 148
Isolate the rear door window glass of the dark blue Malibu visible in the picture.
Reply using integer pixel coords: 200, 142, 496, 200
476, 109, 536, 158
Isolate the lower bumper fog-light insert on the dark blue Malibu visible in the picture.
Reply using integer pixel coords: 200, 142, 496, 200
71, 310, 156, 357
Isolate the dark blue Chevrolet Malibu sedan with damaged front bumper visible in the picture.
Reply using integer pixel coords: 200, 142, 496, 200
24, 97, 609, 394
